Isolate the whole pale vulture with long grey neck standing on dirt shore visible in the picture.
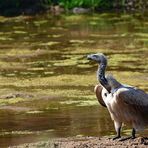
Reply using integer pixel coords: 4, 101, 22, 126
87, 53, 148, 140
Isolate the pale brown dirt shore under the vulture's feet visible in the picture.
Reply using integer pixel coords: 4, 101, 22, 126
9, 137, 148, 148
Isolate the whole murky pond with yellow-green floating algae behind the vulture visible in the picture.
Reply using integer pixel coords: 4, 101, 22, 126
0, 13, 148, 147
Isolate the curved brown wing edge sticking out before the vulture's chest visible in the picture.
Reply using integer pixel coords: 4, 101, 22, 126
94, 85, 106, 107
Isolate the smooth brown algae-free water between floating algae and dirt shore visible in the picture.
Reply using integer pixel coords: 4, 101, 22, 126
0, 107, 113, 146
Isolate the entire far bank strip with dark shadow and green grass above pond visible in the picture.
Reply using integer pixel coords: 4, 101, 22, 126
0, 0, 148, 15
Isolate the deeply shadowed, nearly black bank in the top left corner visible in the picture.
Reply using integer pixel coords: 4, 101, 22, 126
0, 0, 51, 16
